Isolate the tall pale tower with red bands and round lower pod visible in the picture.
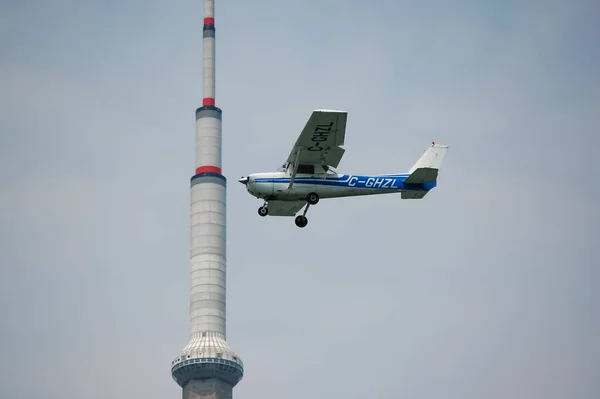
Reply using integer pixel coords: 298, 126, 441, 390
171, 0, 244, 399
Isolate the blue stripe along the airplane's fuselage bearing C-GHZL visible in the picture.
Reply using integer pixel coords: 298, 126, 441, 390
256, 174, 436, 190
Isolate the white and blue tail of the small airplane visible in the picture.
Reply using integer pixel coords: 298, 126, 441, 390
402, 143, 449, 199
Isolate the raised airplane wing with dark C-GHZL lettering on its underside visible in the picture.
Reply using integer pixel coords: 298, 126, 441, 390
287, 109, 348, 168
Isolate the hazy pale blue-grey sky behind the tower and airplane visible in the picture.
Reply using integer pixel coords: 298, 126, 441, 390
0, 0, 600, 399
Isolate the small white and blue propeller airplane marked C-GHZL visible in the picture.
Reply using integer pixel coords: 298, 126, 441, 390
238, 109, 448, 227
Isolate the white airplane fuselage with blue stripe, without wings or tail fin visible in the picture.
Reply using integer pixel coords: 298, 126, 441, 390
246, 172, 436, 201
